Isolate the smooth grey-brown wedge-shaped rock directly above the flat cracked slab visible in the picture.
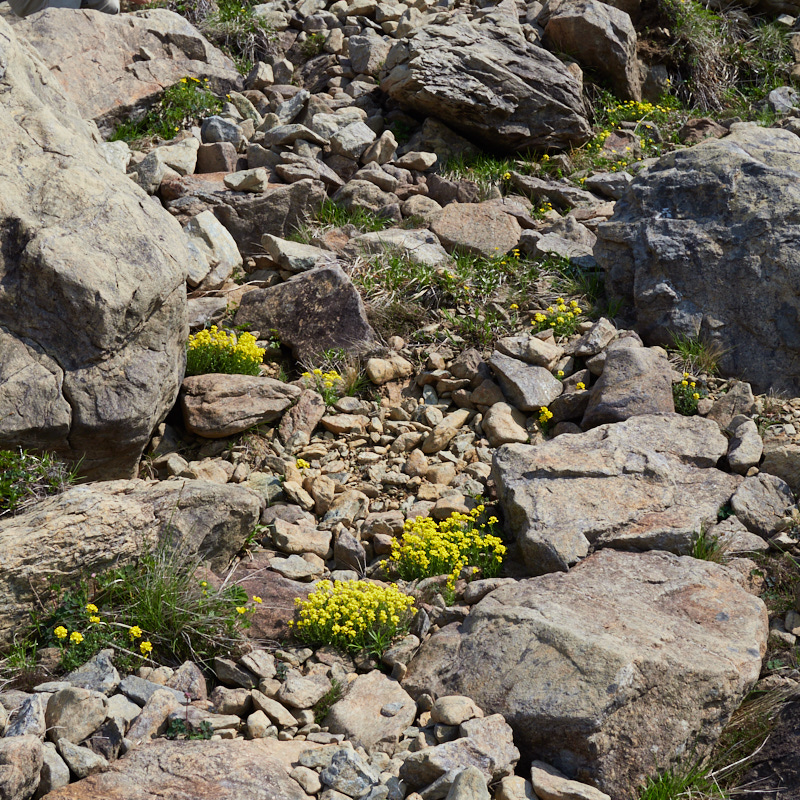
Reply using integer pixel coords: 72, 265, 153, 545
581, 347, 675, 430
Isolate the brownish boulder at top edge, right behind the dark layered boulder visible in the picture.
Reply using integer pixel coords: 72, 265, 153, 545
544, 0, 642, 100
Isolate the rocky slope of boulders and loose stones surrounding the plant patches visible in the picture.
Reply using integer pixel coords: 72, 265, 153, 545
0, 0, 800, 800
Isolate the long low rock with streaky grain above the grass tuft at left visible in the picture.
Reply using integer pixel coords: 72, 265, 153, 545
0, 480, 261, 647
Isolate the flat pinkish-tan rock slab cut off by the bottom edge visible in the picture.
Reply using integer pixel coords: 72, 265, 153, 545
40, 739, 308, 800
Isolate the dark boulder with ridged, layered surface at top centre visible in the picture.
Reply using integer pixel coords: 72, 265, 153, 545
381, 16, 589, 151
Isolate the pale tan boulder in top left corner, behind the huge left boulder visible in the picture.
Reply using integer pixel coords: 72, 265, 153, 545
4, 8, 242, 136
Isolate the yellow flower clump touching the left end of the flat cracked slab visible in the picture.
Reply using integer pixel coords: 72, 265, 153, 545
384, 505, 506, 590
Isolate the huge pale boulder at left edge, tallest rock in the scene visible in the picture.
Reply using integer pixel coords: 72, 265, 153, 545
0, 20, 190, 478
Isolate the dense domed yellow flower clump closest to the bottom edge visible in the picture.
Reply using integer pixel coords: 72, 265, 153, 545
290, 580, 414, 652
